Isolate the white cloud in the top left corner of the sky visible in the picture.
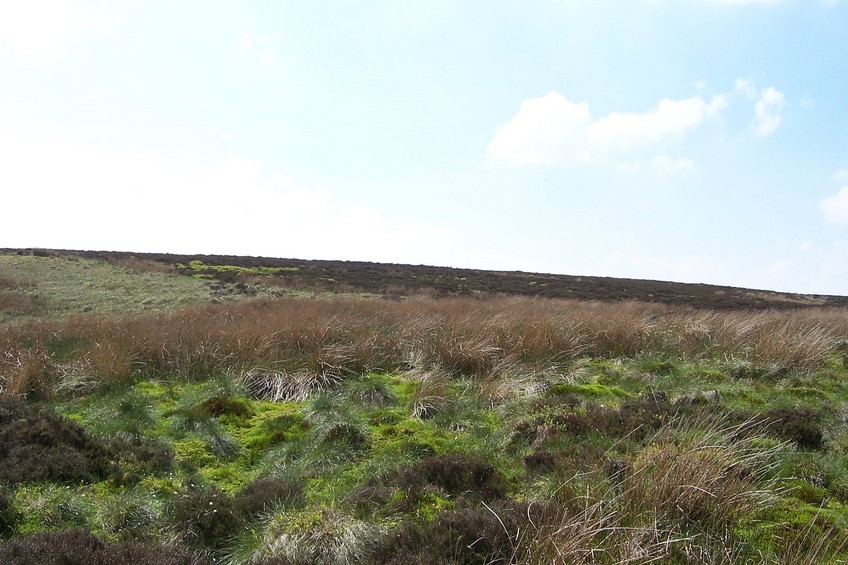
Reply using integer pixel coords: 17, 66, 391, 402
0, 0, 116, 63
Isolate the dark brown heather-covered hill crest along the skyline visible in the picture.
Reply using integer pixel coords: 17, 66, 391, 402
8, 249, 848, 309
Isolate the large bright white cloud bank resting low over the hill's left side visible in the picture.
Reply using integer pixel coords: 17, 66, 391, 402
0, 134, 458, 264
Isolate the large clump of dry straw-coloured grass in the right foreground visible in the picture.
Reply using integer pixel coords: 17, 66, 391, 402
512, 419, 780, 565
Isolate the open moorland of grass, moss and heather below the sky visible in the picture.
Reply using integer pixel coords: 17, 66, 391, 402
0, 254, 848, 565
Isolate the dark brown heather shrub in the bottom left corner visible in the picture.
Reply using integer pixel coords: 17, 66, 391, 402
0, 529, 204, 565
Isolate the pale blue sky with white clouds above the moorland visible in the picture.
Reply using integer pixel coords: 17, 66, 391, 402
0, 0, 848, 295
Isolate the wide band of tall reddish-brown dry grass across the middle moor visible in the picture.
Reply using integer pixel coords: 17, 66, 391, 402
0, 297, 848, 396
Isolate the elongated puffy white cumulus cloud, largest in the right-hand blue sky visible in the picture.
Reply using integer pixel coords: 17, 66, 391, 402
487, 92, 727, 166
